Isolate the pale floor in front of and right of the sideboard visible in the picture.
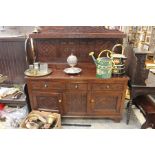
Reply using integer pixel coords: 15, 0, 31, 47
62, 107, 145, 129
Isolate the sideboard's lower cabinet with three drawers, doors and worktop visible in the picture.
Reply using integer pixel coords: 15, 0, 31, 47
26, 69, 128, 121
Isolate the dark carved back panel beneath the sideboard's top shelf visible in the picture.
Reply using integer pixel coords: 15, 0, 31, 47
34, 38, 122, 63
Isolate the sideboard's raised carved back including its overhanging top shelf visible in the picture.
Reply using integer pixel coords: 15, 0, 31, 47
27, 26, 125, 64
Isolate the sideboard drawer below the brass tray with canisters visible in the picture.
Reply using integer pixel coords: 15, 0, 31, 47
31, 81, 65, 90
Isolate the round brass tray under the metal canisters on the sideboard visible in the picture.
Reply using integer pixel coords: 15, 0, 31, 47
24, 69, 52, 77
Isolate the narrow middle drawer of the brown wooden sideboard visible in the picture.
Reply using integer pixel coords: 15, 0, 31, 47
67, 83, 88, 90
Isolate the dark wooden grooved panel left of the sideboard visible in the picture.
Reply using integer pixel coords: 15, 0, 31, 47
0, 38, 27, 84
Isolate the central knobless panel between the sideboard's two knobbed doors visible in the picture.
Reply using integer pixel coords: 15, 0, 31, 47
63, 91, 87, 116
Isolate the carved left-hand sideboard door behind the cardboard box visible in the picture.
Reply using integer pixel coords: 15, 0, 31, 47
32, 91, 62, 113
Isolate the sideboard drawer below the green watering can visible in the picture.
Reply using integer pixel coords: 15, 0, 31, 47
91, 83, 124, 90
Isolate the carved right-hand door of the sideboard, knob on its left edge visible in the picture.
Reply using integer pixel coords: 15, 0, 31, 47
88, 91, 122, 115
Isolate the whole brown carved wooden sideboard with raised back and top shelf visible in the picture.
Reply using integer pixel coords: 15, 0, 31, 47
26, 27, 128, 121
